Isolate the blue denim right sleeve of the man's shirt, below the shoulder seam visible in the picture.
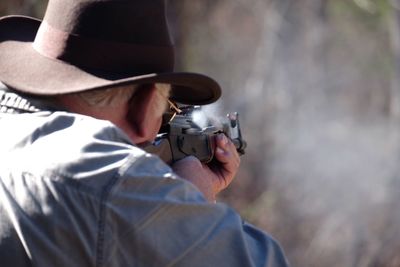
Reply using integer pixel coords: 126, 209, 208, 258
97, 156, 288, 267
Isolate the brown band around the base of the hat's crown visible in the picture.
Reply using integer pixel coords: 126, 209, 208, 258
33, 21, 174, 75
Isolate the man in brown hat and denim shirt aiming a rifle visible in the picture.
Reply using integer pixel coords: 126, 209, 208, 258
0, 0, 287, 267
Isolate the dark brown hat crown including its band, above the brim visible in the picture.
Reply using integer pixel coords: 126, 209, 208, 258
33, 0, 174, 75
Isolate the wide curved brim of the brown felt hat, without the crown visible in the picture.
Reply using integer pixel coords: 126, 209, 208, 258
0, 16, 221, 105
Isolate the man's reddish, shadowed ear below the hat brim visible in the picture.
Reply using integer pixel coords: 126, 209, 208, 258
127, 85, 157, 139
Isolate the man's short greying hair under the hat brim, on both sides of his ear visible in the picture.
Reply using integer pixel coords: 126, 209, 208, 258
78, 83, 171, 115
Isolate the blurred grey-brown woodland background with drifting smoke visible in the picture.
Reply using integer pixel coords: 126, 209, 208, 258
0, 0, 400, 267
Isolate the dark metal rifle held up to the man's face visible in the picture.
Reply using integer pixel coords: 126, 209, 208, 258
144, 106, 246, 164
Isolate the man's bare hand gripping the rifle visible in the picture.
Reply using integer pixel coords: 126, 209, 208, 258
172, 134, 240, 202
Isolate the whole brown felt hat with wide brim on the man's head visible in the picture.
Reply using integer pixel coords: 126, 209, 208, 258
0, 0, 221, 105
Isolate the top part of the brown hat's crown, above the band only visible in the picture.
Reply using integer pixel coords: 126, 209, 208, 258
44, 0, 172, 45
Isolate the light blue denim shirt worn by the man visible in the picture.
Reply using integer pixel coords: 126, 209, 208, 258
0, 108, 287, 267
